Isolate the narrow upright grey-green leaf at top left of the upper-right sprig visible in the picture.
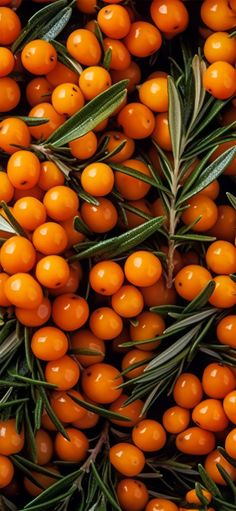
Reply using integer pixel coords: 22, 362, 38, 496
168, 76, 182, 160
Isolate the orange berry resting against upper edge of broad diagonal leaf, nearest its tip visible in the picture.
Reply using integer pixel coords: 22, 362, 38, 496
79, 66, 111, 100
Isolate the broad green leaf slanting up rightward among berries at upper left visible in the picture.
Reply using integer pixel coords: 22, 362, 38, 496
46, 80, 127, 147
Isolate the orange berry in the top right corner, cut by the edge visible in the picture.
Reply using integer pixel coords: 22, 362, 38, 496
201, 0, 236, 31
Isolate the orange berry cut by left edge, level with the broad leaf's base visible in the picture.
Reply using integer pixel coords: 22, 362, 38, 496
0, 117, 31, 154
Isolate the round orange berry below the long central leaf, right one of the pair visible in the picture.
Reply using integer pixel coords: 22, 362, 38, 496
124, 250, 162, 287
